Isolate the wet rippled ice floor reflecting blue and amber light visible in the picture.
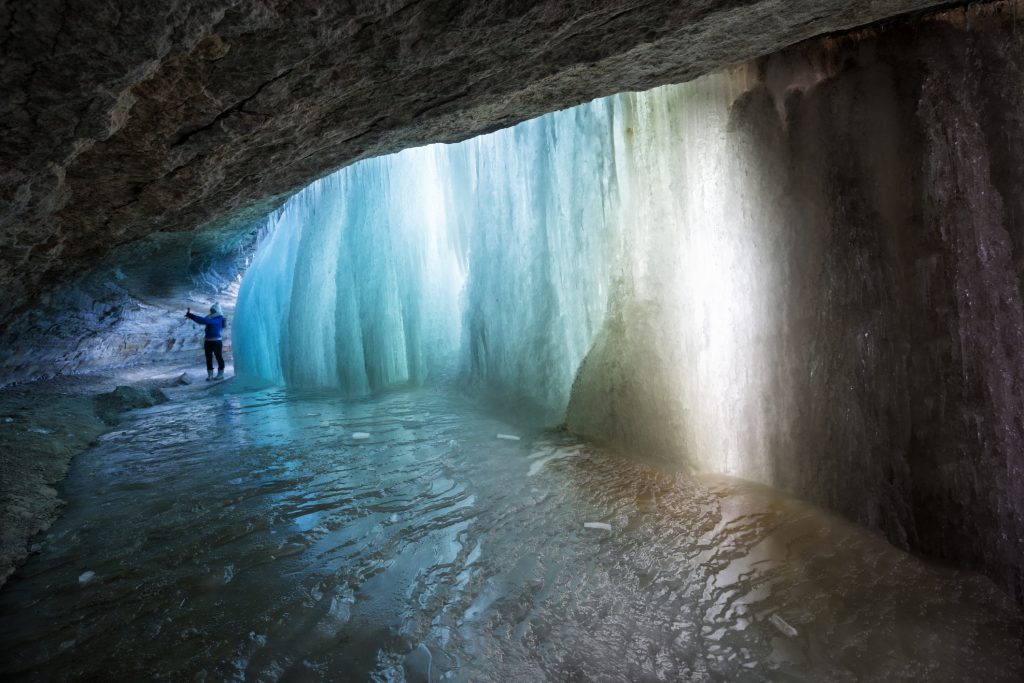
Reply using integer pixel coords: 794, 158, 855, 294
0, 380, 1024, 681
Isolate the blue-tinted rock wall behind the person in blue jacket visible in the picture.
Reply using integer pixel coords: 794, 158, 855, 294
0, 221, 254, 386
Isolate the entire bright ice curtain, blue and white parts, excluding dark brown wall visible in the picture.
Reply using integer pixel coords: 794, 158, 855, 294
233, 68, 765, 442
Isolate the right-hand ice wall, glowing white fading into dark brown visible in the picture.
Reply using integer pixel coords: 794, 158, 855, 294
568, 5, 1024, 600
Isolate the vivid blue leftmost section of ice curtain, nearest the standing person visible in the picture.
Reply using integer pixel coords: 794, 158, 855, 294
232, 147, 465, 394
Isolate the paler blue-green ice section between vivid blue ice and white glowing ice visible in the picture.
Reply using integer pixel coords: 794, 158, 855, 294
445, 107, 617, 411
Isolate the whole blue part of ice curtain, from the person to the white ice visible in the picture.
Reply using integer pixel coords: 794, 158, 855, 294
233, 100, 615, 419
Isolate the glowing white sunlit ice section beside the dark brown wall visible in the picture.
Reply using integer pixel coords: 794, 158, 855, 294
568, 69, 785, 480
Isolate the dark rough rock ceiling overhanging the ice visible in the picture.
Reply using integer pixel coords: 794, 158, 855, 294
0, 0, 935, 322
